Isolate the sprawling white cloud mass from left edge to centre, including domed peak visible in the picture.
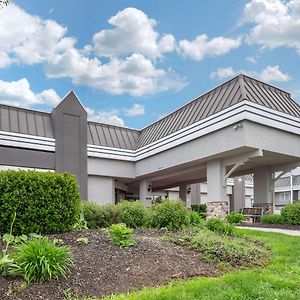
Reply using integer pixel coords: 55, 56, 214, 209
0, 4, 186, 96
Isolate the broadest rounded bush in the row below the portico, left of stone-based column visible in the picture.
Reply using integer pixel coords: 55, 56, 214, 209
151, 199, 189, 230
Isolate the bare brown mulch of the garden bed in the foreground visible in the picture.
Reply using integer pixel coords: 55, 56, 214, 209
0, 230, 221, 300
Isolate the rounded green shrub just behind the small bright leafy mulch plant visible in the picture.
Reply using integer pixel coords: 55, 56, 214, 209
118, 201, 146, 228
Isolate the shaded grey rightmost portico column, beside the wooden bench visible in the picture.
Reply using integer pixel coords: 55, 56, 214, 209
253, 166, 274, 210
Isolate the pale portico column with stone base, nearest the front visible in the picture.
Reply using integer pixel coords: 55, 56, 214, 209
206, 159, 228, 219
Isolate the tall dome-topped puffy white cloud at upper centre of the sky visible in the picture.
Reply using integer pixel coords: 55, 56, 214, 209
93, 7, 175, 58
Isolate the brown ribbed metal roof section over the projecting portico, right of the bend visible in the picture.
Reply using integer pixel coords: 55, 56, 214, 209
138, 75, 300, 148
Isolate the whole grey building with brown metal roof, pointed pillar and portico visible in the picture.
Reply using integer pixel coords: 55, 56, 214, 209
0, 75, 300, 217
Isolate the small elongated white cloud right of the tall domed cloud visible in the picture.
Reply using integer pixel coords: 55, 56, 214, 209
179, 34, 241, 61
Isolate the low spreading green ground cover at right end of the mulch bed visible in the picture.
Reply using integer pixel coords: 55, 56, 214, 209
174, 230, 268, 265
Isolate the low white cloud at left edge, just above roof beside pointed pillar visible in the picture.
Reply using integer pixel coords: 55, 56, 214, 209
0, 78, 61, 107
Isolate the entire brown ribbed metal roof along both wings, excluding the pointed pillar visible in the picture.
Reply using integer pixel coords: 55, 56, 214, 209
0, 75, 300, 150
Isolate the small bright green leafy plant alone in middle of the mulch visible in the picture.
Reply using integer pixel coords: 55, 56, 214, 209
109, 224, 135, 248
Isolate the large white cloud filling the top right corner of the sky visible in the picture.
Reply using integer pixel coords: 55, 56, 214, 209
243, 0, 300, 54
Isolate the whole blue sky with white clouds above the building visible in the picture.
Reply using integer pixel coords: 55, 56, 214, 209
0, 0, 300, 129
